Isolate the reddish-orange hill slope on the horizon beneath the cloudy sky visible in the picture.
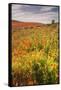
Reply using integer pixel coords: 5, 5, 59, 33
12, 20, 46, 29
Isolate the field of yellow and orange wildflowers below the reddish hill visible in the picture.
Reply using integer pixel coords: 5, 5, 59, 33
12, 23, 59, 86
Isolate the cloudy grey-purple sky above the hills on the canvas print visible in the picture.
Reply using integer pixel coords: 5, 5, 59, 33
12, 4, 58, 24
